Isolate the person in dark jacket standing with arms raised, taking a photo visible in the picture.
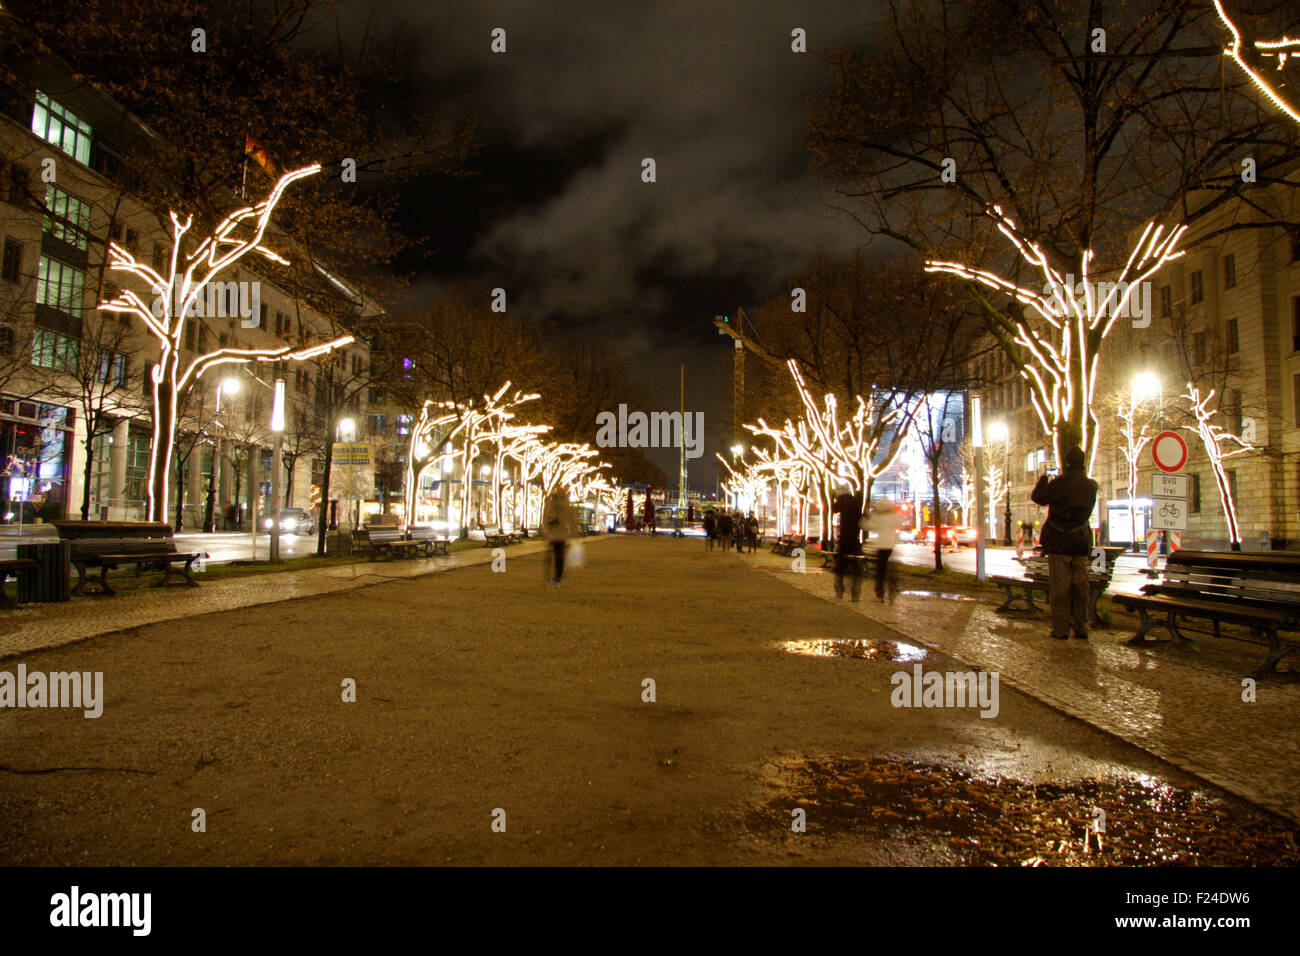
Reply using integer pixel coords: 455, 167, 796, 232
1030, 446, 1097, 640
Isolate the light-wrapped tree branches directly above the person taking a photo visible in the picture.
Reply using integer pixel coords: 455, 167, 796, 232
926, 206, 1187, 472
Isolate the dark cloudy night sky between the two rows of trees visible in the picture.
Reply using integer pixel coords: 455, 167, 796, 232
356, 0, 872, 475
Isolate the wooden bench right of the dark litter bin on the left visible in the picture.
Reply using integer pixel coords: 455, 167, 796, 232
52, 520, 203, 597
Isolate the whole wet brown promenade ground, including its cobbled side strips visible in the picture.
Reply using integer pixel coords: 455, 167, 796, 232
0, 537, 1297, 866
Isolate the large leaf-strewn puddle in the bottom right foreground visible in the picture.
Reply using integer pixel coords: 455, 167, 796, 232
751, 758, 1300, 866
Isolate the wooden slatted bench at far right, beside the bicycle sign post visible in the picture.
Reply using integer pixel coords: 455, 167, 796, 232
1112, 550, 1300, 672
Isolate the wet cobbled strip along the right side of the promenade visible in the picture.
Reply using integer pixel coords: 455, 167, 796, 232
762, 559, 1300, 821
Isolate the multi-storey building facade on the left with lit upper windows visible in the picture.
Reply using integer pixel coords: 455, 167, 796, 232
0, 59, 369, 531
